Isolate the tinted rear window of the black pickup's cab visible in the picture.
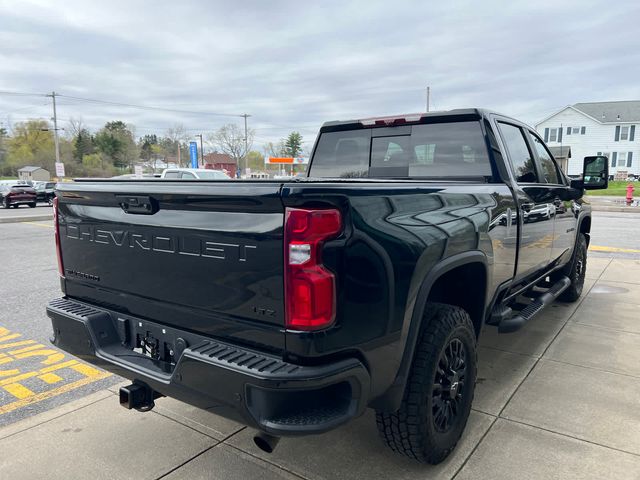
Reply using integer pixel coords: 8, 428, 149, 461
310, 122, 491, 178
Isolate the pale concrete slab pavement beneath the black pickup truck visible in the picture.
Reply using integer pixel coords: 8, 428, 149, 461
0, 257, 640, 480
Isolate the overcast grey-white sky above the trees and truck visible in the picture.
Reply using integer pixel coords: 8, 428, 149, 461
0, 0, 640, 149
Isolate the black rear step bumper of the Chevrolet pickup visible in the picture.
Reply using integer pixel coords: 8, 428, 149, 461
47, 298, 370, 436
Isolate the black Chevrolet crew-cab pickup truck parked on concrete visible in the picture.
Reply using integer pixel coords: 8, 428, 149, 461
47, 109, 608, 463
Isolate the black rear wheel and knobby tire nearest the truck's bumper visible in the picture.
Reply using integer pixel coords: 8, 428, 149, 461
376, 303, 477, 464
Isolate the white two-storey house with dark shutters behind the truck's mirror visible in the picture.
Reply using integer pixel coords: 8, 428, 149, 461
536, 100, 640, 175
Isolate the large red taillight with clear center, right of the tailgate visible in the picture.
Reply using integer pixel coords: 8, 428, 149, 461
284, 208, 342, 330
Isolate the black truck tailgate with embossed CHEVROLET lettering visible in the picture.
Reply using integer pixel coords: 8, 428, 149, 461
58, 180, 284, 350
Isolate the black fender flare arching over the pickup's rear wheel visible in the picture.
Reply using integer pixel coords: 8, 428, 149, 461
384, 250, 491, 411
